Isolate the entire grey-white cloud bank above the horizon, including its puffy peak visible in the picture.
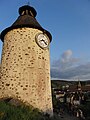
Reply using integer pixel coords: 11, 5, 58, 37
51, 50, 90, 79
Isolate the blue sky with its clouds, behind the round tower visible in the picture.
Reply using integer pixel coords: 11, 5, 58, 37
0, 0, 90, 80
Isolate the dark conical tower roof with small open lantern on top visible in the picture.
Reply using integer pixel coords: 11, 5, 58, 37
0, 5, 52, 41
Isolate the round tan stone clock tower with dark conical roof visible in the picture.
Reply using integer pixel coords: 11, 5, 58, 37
0, 5, 53, 115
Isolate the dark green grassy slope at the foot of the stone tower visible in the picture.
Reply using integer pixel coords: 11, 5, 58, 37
0, 101, 58, 120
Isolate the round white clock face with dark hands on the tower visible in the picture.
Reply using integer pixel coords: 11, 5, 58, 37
36, 33, 50, 48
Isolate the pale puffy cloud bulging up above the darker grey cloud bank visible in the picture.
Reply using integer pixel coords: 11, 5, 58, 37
51, 50, 80, 71
